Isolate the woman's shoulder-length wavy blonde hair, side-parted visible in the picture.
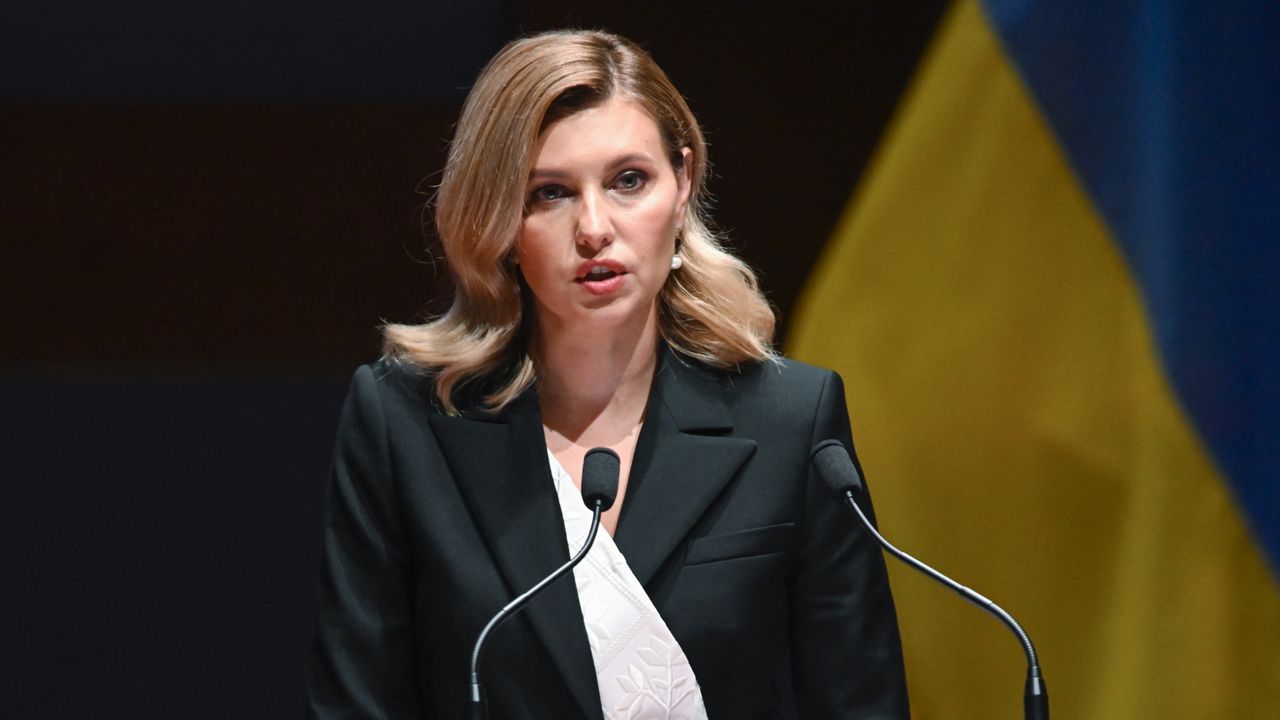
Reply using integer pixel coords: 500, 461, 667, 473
383, 31, 774, 413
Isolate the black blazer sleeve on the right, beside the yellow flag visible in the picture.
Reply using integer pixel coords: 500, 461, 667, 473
791, 373, 910, 720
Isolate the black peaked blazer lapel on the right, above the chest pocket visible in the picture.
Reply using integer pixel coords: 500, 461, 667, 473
613, 350, 755, 584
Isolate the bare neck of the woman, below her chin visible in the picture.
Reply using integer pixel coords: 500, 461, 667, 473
535, 303, 658, 441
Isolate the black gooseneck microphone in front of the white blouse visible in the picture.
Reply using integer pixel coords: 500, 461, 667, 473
465, 447, 622, 720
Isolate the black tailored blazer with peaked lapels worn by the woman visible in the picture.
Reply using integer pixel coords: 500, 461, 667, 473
307, 350, 908, 720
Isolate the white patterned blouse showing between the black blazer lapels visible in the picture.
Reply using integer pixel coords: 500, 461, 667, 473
547, 450, 707, 720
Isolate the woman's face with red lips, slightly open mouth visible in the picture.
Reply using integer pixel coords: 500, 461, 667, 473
516, 96, 690, 332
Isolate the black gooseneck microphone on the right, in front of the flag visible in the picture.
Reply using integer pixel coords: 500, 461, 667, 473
809, 439, 1048, 720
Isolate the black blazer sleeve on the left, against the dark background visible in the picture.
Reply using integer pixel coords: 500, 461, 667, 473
306, 365, 420, 720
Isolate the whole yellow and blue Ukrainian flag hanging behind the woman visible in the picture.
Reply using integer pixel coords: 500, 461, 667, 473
788, 0, 1280, 720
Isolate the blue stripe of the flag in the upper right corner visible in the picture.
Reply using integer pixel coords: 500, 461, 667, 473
983, 0, 1280, 571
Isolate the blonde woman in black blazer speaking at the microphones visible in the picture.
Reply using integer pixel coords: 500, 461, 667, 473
310, 32, 908, 720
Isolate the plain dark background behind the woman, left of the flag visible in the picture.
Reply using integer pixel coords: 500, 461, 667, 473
0, 0, 945, 719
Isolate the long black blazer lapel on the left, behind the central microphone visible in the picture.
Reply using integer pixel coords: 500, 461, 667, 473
430, 391, 602, 717
